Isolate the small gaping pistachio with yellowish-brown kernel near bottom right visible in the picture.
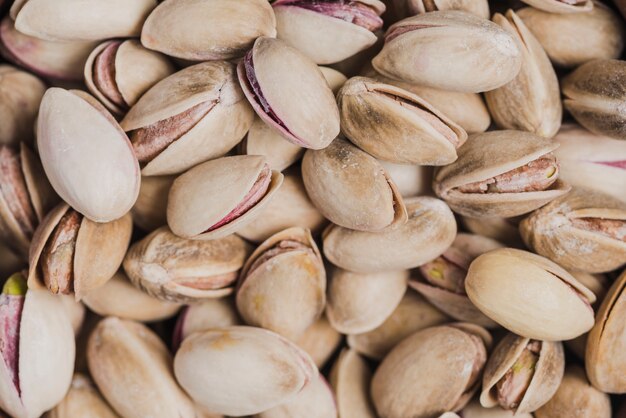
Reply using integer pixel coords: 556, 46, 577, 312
480, 334, 565, 413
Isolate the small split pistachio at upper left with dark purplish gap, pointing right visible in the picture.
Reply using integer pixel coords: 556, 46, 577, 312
85, 39, 174, 115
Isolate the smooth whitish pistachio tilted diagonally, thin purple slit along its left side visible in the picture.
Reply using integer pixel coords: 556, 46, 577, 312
237, 36, 339, 149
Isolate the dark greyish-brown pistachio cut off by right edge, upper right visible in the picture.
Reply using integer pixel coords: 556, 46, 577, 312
561, 60, 626, 139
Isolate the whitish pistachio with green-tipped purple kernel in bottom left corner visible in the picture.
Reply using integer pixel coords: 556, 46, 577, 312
0, 273, 75, 418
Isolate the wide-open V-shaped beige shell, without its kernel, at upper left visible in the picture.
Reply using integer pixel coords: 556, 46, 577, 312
120, 61, 254, 176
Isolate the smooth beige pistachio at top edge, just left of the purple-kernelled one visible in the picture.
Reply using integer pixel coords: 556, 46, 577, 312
141, 0, 276, 61
